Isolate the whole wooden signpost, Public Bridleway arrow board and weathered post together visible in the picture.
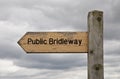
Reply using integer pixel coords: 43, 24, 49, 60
18, 10, 104, 79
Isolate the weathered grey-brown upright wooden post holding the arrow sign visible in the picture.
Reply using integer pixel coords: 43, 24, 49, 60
88, 10, 104, 79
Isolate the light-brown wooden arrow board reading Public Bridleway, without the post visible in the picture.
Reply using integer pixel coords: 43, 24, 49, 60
18, 32, 88, 53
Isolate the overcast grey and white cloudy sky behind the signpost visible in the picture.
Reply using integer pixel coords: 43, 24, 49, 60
0, 0, 120, 79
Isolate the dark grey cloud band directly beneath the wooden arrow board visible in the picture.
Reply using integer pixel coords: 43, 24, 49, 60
15, 55, 87, 69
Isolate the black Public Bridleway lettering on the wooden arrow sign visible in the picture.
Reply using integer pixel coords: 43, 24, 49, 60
27, 38, 82, 46
